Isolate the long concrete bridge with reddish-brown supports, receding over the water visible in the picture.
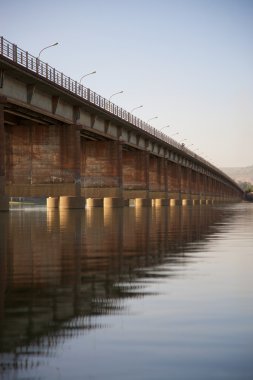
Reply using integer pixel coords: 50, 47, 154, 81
0, 37, 243, 210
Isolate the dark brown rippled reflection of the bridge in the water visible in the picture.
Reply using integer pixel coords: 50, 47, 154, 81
0, 206, 232, 373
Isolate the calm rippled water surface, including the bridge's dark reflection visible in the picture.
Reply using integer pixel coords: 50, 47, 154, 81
0, 203, 253, 380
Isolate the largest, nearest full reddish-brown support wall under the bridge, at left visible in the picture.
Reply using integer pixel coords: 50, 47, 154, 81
6, 123, 80, 197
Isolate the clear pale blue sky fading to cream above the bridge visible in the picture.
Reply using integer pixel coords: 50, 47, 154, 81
0, 0, 253, 168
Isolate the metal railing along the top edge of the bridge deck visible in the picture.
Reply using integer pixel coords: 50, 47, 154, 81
0, 37, 237, 186
